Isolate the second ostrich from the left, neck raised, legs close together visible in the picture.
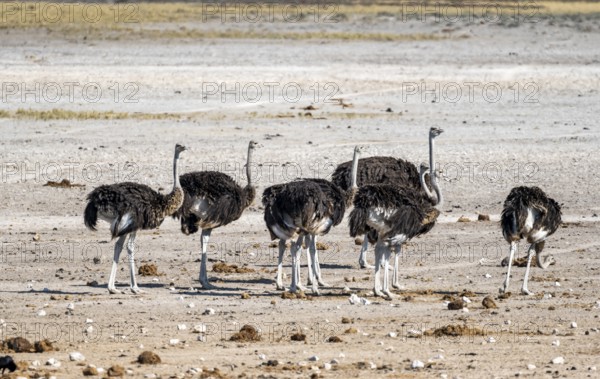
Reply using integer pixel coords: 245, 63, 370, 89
173, 141, 258, 289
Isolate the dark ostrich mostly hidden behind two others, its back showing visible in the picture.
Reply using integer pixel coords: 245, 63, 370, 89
331, 142, 432, 268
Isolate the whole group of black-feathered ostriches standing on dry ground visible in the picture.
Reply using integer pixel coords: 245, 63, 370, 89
84, 128, 561, 298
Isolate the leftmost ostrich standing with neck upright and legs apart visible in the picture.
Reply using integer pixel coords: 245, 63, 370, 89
84, 144, 185, 294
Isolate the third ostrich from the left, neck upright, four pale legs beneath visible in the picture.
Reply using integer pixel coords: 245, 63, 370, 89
262, 146, 364, 295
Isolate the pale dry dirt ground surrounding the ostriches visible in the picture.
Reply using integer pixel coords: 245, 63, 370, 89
0, 2, 600, 378
